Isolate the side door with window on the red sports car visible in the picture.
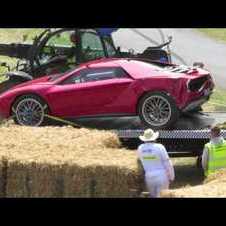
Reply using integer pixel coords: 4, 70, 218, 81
49, 68, 135, 117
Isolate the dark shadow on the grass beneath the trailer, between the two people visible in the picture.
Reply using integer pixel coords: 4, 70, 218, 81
170, 164, 204, 189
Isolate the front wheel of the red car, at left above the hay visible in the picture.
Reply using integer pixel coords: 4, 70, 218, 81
12, 95, 49, 127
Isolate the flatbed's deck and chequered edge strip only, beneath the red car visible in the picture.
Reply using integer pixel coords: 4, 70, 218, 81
75, 112, 226, 139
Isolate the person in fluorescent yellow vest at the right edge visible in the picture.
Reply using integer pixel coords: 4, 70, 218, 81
202, 126, 226, 177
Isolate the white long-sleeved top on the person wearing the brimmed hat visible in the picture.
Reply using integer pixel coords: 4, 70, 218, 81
138, 143, 175, 181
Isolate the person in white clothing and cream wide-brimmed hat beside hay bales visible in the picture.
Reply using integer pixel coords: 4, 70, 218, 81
138, 129, 175, 198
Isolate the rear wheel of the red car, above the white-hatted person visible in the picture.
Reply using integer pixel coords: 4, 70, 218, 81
138, 92, 179, 130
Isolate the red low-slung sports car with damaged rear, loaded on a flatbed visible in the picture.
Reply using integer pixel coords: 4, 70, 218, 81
0, 59, 214, 129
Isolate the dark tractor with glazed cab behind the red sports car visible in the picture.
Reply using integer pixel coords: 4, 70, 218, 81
0, 28, 178, 94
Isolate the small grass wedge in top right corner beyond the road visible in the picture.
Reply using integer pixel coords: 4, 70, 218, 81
198, 28, 226, 42
